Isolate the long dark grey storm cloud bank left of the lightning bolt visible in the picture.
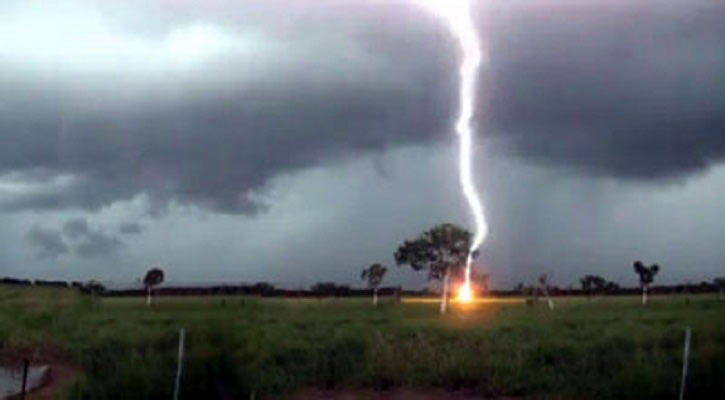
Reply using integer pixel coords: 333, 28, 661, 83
0, 0, 453, 214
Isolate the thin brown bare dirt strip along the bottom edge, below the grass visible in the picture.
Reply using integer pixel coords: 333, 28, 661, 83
291, 389, 526, 400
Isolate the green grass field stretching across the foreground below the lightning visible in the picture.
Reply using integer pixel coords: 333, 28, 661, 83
0, 287, 725, 399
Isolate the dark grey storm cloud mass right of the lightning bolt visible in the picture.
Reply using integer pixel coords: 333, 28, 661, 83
486, 0, 725, 179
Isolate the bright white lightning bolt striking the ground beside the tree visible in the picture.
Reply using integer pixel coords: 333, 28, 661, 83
417, 0, 488, 302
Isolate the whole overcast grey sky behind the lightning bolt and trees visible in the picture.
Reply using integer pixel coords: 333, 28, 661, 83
0, 0, 725, 288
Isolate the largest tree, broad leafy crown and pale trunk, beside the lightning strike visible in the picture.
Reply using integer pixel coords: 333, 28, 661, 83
395, 224, 471, 314
